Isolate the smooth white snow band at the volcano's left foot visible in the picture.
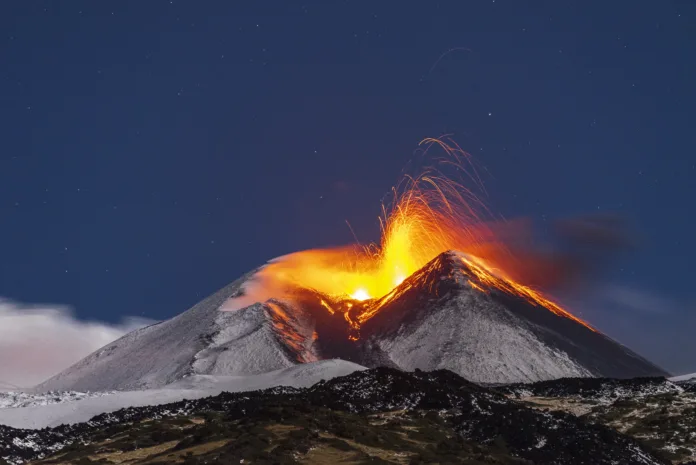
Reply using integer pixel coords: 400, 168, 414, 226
0, 360, 365, 429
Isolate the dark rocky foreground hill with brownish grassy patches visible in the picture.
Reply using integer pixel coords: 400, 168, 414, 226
0, 368, 669, 465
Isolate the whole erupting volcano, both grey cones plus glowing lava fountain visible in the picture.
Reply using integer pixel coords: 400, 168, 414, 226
38, 139, 666, 391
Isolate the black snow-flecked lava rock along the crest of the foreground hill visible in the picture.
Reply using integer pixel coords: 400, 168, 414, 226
0, 368, 668, 465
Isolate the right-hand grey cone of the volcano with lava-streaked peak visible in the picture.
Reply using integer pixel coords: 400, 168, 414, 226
360, 252, 666, 383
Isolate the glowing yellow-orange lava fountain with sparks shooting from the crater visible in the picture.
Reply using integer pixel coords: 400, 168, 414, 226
242, 139, 592, 329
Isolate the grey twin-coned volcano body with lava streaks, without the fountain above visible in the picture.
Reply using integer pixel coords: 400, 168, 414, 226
37, 252, 667, 391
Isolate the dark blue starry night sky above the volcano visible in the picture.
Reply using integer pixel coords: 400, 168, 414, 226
0, 0, 696, 371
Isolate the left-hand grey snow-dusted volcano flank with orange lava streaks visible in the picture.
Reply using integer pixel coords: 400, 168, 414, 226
35, 272, 317, 392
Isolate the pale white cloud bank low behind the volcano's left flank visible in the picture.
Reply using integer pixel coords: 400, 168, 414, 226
0, 299, 153, 387
